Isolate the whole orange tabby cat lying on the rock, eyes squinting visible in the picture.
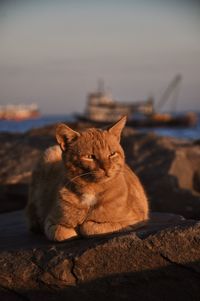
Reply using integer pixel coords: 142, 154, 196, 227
26, 116, 149, 241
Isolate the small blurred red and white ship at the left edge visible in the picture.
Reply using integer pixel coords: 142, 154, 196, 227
0, 104, 40, 121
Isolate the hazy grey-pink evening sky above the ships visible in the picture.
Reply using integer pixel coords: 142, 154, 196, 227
0, 0, 200, 114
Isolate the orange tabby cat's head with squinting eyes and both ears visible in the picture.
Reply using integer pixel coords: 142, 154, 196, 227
56, 117, 126, 183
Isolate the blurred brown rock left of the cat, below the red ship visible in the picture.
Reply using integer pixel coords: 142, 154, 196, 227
0, 126, 55, 184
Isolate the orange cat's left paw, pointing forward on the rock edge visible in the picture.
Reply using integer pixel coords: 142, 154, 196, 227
45, 222, 77, 241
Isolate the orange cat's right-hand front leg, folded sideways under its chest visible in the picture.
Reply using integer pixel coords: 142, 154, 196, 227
79, 221, 128, 237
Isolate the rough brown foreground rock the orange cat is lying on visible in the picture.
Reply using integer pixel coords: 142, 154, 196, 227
0, 211, 200, 301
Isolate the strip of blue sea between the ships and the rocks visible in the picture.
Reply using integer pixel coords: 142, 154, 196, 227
0, 113, 200, 140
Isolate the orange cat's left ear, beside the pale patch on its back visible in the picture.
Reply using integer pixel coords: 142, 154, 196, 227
56, 123, 80, 151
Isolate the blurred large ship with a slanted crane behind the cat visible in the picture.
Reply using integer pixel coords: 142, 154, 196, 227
77, 75, 197, 127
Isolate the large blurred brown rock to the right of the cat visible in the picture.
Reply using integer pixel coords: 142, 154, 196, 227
123, 133, 200, 219
